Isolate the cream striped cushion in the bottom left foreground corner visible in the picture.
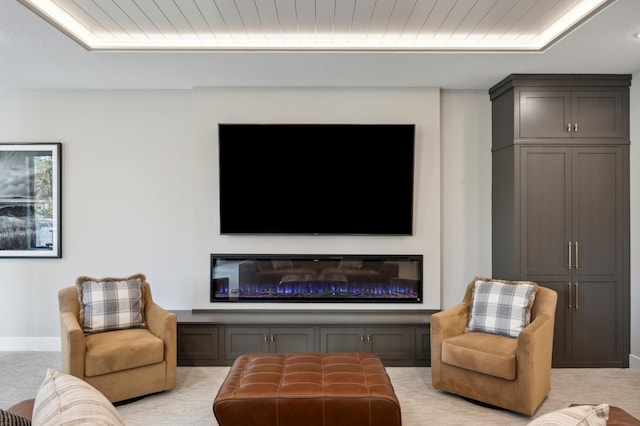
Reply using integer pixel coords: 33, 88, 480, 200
31, 368, 124, 426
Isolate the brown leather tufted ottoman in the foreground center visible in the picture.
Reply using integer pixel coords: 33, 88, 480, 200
213, 353, 402, 426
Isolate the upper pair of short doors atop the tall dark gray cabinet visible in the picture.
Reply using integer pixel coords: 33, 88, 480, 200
518, 90, 627, 142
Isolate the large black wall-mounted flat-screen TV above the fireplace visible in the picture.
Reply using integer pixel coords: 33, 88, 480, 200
218, 124, 415, 235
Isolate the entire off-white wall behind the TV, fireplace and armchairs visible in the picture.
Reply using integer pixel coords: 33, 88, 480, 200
0, 85, 640, 369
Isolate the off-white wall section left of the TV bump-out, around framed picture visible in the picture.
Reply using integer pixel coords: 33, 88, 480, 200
0, 91, 196, 349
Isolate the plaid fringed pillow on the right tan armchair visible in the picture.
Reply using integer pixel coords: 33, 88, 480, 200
465, 280, 536, 337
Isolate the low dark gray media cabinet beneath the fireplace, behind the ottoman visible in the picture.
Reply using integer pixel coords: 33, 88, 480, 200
173, 310, 437, 367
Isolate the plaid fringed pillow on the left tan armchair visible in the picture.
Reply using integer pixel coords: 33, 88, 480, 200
77, 275, 144, 333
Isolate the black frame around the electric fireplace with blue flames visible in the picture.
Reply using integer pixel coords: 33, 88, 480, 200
209, 253, 424, 305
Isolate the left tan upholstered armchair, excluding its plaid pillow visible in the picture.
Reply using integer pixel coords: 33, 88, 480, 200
58, 275, 177, 402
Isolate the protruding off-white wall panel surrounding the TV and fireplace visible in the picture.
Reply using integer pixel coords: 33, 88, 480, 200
192, 88, 440, 309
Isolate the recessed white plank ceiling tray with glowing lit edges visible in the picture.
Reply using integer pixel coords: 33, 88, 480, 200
18, 0, 615, 51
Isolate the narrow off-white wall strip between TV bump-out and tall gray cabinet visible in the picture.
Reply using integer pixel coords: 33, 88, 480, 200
440, 91, 491, 307
